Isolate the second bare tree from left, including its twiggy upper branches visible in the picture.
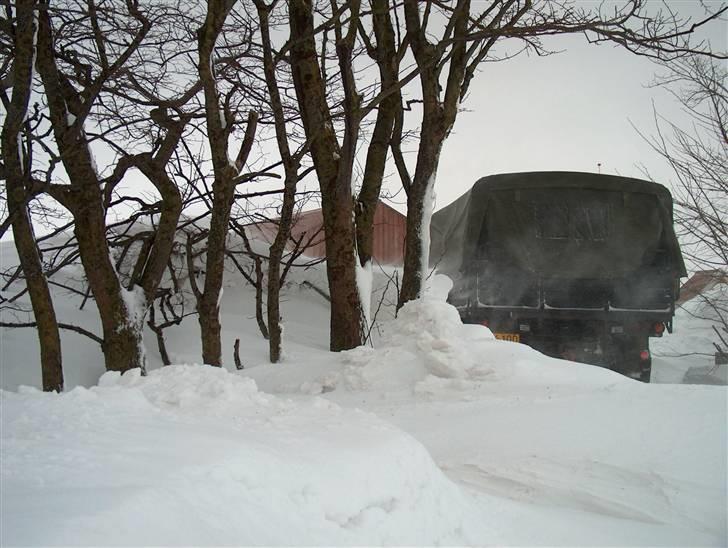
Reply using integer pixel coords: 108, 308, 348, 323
31, 2, 189, 371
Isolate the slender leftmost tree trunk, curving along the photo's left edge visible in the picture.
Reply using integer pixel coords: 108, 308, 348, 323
1, 0, 63, 392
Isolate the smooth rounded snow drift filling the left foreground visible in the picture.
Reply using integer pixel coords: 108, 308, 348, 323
0, 366, 492, 545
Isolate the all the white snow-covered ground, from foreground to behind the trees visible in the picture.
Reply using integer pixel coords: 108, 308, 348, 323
0, 244, 728, 546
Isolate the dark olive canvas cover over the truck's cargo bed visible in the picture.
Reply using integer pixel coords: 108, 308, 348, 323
430, 172, 686, 285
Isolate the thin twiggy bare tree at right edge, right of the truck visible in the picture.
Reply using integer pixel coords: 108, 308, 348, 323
643, 55, 728, 359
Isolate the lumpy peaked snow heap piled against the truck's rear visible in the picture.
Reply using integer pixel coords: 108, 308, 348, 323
316, 276, 626, 394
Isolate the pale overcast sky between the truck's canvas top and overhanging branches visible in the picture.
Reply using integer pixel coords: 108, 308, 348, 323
416, 0, 728, 209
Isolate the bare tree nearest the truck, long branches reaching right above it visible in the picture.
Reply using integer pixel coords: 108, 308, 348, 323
394, 0, 728, 306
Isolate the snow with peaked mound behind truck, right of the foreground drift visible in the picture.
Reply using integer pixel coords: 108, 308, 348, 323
244, 278, 728, 546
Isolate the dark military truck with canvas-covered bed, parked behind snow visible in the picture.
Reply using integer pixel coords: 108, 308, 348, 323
430, 172, 686, 382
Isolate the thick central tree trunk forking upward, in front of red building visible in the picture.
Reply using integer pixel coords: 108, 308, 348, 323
289, 0, 364, 351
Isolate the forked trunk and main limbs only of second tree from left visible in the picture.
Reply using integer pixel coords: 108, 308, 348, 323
36, 2, 189, 372
